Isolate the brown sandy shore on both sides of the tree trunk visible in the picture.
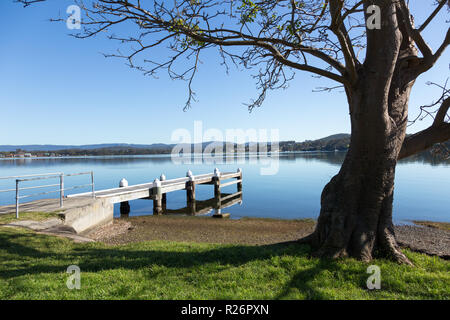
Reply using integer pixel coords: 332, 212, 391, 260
87, 216, 450, 259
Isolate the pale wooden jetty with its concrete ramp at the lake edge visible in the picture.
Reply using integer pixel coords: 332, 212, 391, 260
0, 169, 242, 234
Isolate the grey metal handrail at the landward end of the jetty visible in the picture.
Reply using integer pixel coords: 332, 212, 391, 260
0, 171, 95, 218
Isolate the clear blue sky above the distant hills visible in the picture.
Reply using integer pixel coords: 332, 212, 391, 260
0, 0, 450, 145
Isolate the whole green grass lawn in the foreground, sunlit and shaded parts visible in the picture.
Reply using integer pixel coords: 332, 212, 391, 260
0, 228, 450, 299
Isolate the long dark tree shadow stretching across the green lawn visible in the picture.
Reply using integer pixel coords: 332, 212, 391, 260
0, 229, 352, 299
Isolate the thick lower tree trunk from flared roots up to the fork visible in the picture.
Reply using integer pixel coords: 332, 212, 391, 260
310, 79, 412, 264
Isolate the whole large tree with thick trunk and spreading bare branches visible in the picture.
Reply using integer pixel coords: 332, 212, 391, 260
17, 0, 450, 264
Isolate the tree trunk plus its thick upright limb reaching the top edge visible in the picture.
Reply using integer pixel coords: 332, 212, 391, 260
303, 1, 417, 264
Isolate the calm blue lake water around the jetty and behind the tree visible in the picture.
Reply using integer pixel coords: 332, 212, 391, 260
0, 152, 450, 223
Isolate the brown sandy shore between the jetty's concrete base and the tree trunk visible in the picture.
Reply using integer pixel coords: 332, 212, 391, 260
88, 216, 314, 245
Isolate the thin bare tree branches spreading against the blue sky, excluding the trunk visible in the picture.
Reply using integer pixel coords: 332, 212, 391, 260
15, 0, 450, 128
